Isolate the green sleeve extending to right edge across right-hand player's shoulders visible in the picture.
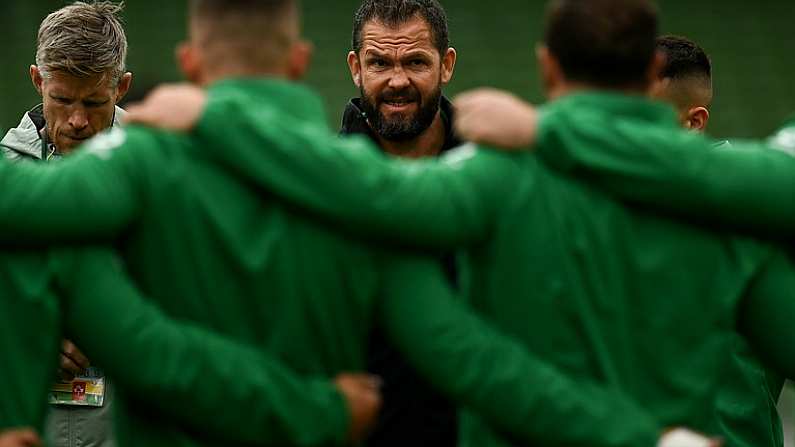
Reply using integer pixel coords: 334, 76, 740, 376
537, 116, 795, 236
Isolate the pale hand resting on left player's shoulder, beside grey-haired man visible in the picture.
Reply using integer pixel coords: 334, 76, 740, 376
124, 84, 207, 132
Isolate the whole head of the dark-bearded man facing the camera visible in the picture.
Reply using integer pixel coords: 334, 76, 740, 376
348, 0, 456, 141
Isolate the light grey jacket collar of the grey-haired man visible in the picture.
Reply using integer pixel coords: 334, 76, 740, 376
0, 104, 127, 160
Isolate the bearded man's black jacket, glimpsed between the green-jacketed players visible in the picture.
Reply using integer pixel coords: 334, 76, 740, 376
340, 97, 461, 447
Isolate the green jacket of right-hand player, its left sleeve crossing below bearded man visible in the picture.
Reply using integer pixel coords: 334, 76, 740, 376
188, 86, 795, 445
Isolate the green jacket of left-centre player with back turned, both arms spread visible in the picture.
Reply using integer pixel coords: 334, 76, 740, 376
0, 80, 662, 447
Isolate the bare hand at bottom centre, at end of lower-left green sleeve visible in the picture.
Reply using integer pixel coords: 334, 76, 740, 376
334, 374, 381, 443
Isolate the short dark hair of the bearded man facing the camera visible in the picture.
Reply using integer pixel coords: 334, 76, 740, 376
352, 0, 450, 55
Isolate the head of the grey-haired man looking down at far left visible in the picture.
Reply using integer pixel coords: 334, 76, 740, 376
30, 2, 132, 152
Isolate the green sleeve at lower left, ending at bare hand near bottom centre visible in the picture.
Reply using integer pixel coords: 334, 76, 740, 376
58, 249, 349, 446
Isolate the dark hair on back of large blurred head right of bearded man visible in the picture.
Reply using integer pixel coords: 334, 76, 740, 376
545, 0, 658, 87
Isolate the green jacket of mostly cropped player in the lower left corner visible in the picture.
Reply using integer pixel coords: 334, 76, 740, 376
0, 249, 347, 443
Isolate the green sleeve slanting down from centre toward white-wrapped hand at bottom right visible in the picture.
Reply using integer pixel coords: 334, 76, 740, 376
380, 254, 662, 447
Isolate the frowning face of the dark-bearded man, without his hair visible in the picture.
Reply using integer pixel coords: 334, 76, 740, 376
348, 17, 455, 141
